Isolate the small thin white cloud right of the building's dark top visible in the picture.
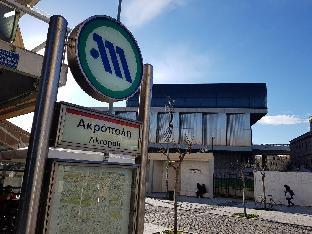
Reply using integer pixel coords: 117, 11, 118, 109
258, 115, 308, 125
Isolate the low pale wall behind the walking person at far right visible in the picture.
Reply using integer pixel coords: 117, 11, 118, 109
254, 171, 312, 206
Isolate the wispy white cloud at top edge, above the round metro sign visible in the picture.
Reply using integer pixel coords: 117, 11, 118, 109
121, 0, 185, 27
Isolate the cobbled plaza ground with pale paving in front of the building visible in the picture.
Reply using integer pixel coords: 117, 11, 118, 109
144, 198, 312, 234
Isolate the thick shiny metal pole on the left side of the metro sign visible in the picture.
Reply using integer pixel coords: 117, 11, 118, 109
17, 15, 67, 234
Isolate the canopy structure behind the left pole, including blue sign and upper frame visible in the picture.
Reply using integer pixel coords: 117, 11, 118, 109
0, 0, 68, 120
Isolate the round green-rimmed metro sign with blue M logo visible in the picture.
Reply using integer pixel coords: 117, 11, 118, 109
68, 16, 143, 101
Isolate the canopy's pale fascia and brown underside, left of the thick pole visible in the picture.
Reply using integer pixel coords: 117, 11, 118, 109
0, 38, 68, 120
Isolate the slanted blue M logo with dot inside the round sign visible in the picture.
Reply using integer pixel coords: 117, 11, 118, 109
90, 33, 132, 83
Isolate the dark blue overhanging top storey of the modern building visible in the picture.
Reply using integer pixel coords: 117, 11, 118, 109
127, 83, 267, 124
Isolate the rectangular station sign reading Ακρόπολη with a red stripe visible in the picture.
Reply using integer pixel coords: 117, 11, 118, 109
54, 103, 141, 156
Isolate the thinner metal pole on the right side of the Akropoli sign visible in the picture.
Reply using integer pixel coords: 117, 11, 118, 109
136, 64, 153, 234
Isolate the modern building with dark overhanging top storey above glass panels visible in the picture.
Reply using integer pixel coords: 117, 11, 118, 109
111, 84, 267, 197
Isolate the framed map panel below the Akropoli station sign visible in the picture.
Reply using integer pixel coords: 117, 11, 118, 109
45, 162, 137, 234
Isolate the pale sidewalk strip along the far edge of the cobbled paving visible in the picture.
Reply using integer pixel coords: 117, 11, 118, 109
145, 196, 312, 233
